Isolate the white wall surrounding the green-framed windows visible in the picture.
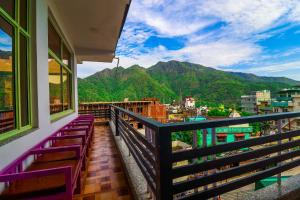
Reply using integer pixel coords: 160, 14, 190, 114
0, 0, 78, 170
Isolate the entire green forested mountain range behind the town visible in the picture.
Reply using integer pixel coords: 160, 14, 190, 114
78, 61, 300, 105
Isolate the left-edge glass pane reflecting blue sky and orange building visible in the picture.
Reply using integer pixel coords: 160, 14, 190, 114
0, 17, 15, 134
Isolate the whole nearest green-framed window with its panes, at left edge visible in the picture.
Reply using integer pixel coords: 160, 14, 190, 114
0, 0, 31, 137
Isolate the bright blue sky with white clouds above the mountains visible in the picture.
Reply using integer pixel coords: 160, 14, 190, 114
78, 0, 300, 80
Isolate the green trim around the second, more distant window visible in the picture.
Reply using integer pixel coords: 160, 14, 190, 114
47, 17, 75, 122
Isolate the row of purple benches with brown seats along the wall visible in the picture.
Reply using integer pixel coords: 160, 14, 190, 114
0, 116, 94, 200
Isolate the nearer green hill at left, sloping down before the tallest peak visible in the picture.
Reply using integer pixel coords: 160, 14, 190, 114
78, 65, 177, 101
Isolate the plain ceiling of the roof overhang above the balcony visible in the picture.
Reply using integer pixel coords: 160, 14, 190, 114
51, 0, 130, 62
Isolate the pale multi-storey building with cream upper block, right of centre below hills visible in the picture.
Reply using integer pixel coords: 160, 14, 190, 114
241, 90, 271, 114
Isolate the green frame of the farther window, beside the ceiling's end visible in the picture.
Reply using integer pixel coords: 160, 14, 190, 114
48, 16, 75, 119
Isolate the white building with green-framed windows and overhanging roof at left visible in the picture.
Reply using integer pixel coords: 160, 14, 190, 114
0, 0, 130, 199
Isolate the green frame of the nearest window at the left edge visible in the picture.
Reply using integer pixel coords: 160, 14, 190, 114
0, 0, 33, 145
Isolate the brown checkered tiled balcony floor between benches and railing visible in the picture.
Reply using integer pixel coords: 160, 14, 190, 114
74, 125, 133, 200
